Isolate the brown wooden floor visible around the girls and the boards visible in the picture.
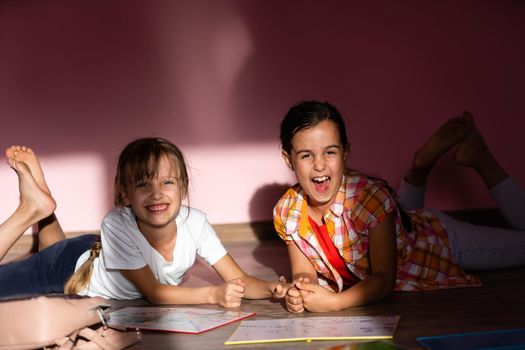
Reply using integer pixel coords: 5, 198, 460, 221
103, 241, 525, 350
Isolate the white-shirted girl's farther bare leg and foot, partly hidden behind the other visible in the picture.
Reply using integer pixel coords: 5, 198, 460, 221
6, 146, 65, 250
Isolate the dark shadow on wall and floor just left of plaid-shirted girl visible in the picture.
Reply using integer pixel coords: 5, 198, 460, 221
250, 183, 291, 278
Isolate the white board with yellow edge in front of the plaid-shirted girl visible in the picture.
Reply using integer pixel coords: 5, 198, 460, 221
224, 316, 399, 345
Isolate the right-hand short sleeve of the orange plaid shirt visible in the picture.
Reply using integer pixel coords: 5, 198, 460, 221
350, 182, 397, 233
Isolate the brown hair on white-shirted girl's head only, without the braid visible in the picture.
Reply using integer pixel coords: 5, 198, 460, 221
114, 137, 188, 206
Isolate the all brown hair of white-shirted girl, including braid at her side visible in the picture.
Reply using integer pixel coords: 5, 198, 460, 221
64, 137, 189, 294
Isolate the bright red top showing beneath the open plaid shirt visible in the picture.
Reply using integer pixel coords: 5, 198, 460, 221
308, 216, 360, 287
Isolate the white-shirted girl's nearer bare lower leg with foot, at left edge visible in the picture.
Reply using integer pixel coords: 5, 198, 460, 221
0, 158, 56, 259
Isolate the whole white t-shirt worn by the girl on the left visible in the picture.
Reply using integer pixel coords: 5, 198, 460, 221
75, 206, 226, 299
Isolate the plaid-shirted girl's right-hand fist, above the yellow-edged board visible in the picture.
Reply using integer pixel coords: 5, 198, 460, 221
295, 281, 340, 312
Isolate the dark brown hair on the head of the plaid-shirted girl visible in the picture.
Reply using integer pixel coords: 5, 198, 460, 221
279, 101, 348, 154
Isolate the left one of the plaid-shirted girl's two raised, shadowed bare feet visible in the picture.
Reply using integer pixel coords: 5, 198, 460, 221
405, 112, 474, 187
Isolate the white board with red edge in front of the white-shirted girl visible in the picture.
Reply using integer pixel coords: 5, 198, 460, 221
108, 307, 255, 334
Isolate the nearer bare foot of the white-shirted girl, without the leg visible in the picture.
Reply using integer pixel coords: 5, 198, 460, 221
8, 158, 56, 223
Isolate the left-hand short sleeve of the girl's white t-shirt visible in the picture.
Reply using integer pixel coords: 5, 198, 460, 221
101, 208, 146, 270
